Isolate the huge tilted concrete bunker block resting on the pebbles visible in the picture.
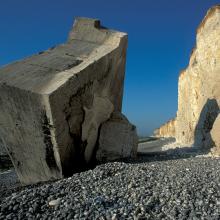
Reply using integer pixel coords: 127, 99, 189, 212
0, 18, 127, 184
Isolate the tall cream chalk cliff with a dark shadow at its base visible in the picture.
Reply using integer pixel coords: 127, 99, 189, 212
176, 6, 220, 147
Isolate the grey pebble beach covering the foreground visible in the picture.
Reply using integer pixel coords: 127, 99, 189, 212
0, 155, 220, 220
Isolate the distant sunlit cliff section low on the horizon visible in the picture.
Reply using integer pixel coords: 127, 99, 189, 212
154, 119, 176, 137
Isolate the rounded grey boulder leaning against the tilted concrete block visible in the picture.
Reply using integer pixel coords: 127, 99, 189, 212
96, 112, 138, 162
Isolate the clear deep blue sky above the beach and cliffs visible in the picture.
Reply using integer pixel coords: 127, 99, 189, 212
0, 0, 219, 135
